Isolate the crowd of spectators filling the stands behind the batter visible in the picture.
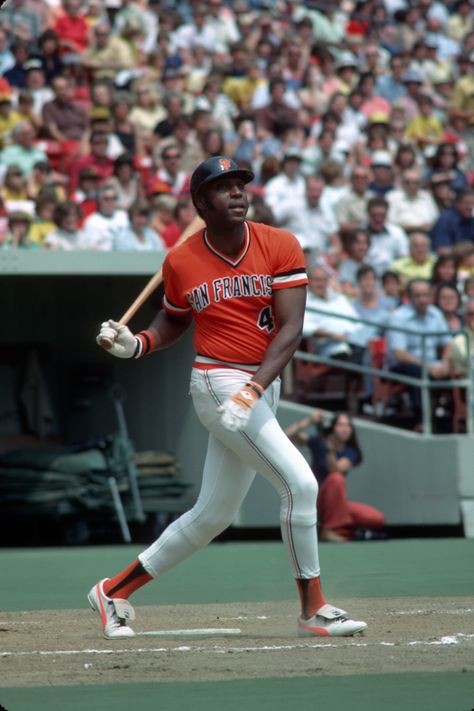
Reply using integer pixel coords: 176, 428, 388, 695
0, 0, 474, 422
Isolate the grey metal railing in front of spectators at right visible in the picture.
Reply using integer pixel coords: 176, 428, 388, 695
293, 306, 474, 435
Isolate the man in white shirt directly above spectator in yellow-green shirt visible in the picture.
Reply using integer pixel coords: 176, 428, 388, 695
387, 168, 439, 232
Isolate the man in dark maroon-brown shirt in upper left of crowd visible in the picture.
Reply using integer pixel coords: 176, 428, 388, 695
42, 76, 89, 147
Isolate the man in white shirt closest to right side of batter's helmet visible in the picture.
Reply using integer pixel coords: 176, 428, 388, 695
263, 151, 306, 229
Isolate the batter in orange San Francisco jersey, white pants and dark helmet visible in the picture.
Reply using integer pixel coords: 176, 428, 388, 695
89, 156, 367, 639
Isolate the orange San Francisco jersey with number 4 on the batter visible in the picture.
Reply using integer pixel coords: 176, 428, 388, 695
163, 222, 308, 367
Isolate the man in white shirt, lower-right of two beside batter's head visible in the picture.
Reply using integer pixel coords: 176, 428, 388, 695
287, 176, 339, 257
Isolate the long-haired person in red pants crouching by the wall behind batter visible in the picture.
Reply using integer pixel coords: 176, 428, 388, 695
286, 411, 384, 543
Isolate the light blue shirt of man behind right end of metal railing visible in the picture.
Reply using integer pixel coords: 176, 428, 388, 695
387, 304, 451, 364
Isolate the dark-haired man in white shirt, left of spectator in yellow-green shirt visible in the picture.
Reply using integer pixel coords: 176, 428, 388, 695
366, 197, 408, 278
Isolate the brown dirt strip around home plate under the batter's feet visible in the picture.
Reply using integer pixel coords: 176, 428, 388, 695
0, 597, 474, 687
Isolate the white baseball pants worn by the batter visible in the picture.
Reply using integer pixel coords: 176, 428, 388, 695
138, 368, 320, 578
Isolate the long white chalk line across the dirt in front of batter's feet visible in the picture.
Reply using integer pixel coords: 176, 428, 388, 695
0, 632, 474, 658
